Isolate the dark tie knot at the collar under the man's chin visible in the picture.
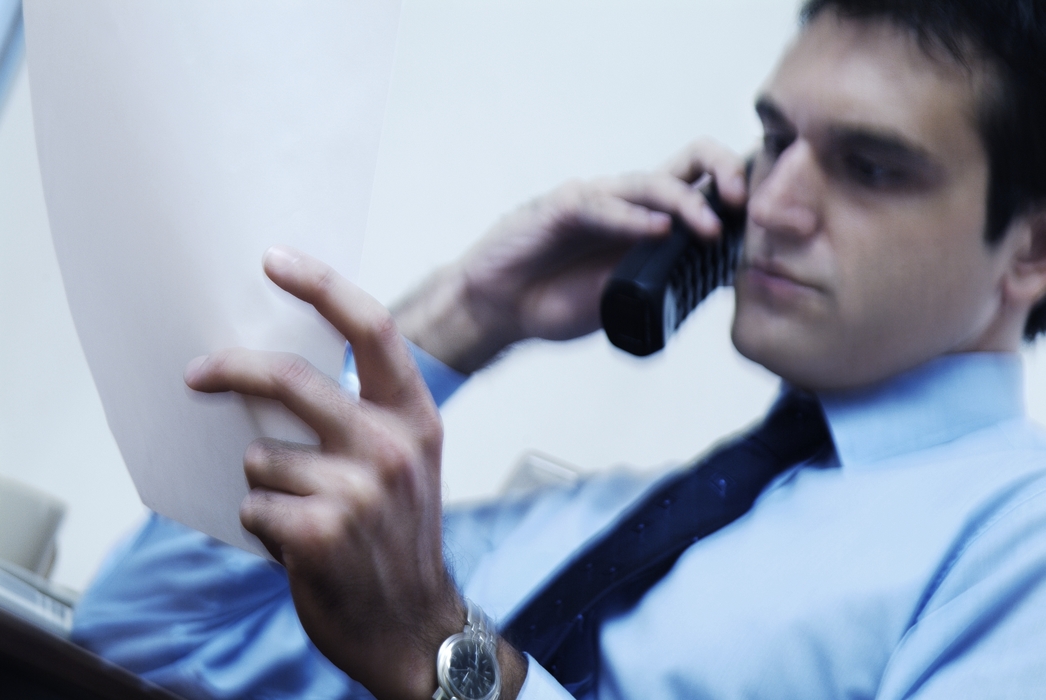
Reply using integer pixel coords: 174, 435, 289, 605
752, 389, 832, 464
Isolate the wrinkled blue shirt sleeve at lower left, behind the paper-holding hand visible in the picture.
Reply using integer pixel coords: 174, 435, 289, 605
72, 514, 371, 700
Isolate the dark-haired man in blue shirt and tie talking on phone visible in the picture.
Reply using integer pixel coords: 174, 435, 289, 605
77, 0, 1046, 699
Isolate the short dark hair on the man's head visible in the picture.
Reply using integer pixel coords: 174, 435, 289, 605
799, 0, 1046, 340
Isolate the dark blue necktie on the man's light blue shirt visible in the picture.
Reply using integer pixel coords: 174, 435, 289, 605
502, 391, 832, 695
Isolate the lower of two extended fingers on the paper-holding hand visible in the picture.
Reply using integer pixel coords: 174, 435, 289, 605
185, 347, 359, 445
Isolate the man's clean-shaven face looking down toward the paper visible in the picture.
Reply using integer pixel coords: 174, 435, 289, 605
733, 13, 1006, 389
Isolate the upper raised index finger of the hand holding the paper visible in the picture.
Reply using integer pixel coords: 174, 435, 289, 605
264, 246, 428, 403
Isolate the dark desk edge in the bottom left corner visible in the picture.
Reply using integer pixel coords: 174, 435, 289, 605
0, 610, 179, 700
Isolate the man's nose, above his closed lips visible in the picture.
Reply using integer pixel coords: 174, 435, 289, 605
748, 140, 820, 238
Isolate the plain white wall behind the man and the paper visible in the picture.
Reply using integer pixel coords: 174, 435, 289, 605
6, 0, 1046, 588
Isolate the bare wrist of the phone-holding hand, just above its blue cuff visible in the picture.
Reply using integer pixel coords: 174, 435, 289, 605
392, 265, 519, 375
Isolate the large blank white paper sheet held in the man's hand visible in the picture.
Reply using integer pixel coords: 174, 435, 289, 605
25, 0, 400, 552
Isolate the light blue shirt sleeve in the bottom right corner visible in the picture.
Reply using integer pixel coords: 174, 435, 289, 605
878, 488, 1046, 700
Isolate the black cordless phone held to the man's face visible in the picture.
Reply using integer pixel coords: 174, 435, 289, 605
599, 182, 746, 357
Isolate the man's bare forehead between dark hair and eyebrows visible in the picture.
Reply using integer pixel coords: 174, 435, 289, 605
765, 12, 984, 166
